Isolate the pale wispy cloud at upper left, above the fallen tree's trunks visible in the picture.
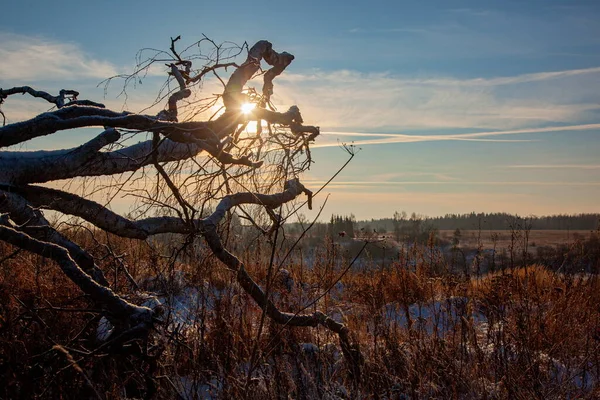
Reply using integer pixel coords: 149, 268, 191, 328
0, 31, 227, 123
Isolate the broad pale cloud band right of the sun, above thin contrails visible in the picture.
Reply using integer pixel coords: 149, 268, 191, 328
274, 67, 600, 131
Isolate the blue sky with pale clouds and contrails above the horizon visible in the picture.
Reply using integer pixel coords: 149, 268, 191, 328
0, 0, 600, 219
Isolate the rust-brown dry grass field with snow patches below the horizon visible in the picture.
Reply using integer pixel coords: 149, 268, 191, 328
0, 229, 600, 400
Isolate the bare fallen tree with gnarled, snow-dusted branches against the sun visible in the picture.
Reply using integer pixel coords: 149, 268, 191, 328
0, 38, 360, 390
